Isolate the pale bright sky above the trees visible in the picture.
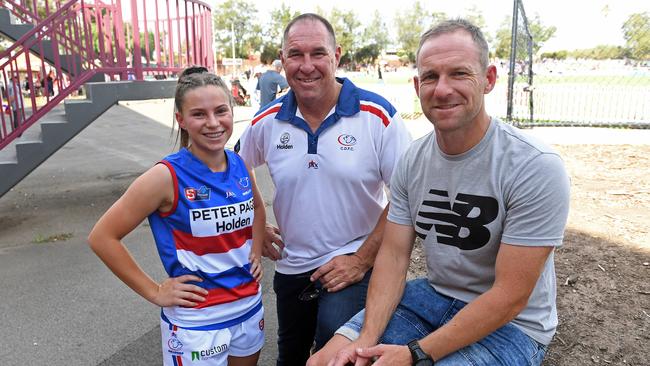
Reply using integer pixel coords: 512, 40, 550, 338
208, 0, 650, 52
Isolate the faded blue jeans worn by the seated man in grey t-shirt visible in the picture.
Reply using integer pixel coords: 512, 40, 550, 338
337, 278, 546, 366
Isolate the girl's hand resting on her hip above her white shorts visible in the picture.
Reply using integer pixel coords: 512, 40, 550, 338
152, 275, 208, 307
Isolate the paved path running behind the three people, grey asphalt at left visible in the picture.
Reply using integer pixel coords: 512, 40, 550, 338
0, 101, 650, 366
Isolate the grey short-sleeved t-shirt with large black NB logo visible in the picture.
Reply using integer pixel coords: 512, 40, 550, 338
388, 119, 570, 344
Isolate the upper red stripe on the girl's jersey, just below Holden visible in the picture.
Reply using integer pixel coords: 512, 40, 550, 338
172, 226, 253, 255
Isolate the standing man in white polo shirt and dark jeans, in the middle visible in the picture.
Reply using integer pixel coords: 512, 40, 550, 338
240, 13, 410, 366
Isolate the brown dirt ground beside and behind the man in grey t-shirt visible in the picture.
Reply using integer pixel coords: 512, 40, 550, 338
410, 145, 650, 366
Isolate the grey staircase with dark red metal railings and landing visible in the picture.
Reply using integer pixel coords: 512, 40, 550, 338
0, 0, 214, 196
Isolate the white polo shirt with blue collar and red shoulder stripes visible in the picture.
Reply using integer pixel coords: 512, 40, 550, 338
239, 78, 411, 274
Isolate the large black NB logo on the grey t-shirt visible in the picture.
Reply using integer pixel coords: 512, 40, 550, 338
415, 189, 499, 250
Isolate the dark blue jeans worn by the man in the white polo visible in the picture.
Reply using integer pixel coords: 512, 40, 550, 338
273, 270, 372, 366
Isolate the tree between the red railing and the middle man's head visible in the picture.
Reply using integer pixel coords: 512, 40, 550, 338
213, 0, 263, 58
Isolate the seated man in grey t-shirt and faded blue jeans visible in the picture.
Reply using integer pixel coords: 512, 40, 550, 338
308, 20, 569, 366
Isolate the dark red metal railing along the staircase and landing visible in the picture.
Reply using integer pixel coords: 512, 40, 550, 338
0, 0, 214, 149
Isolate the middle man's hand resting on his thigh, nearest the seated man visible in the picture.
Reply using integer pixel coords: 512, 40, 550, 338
310, 254, 369, 292
